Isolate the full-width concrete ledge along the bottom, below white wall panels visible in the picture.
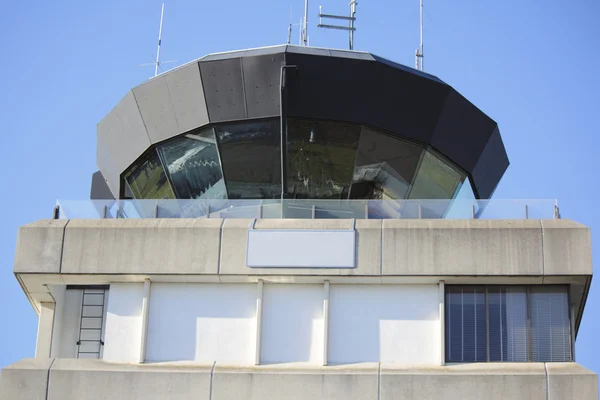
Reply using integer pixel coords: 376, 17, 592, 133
0, 359, 598, 400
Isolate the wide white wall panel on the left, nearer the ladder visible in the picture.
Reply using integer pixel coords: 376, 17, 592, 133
146, 283, 256, 364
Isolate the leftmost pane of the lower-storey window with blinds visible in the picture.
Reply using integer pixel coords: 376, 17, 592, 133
446, 286, 487, 362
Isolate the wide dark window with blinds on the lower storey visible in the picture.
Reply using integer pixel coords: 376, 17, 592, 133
445, 285, 571, 362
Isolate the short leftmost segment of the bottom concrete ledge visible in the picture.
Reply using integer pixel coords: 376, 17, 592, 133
0, 358, 54, 400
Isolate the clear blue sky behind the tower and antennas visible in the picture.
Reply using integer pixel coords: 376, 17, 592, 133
0, 0, 600, 371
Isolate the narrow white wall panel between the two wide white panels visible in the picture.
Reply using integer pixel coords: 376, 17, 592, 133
261, 284, 323, 364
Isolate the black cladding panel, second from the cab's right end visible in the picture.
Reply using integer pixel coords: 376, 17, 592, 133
431, 89, 496, 172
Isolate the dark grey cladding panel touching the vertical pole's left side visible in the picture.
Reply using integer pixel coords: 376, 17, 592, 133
242, 53, 284, 118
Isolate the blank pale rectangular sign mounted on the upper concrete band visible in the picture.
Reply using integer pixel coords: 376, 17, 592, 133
246, 229, 356, 268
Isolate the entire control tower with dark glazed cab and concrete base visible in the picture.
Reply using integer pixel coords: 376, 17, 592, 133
0, 45, 598, 400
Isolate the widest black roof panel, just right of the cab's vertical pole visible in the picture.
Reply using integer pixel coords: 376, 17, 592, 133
286, 53, 449, 143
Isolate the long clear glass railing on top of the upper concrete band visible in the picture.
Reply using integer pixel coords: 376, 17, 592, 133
55, 199, 560, 219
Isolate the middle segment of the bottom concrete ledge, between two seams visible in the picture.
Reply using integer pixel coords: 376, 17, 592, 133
212, 363, 378, 400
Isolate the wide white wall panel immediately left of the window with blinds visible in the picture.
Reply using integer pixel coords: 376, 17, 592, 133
328, 285, 440, 365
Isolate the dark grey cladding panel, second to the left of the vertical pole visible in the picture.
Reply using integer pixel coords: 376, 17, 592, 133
199, 58, 247, 122
